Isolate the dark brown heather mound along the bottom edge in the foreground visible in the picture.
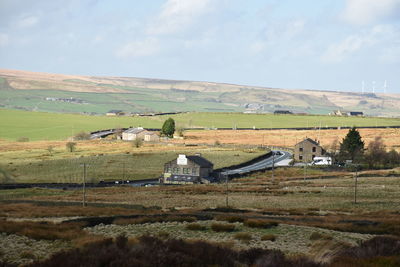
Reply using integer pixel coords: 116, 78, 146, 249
27, 236, 320, 267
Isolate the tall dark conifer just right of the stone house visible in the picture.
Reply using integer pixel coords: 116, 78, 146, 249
339, 127, 364, 161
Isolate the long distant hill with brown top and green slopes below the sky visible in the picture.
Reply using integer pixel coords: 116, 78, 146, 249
0, 69, 400, 116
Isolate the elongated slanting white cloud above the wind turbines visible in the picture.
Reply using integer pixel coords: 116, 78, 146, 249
322, 25, 396, 62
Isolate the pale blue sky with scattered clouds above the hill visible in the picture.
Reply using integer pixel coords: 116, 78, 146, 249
0, 0, 400, 93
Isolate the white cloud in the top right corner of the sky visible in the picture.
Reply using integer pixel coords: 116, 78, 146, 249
342, 0, 400, 25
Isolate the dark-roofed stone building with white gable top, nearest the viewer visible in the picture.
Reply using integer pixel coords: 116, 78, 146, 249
162, 155, 214, 184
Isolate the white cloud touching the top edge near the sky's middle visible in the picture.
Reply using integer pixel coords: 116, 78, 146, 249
147, 0, 211, 35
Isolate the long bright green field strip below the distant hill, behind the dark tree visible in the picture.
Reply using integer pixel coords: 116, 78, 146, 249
0, 109, 400, 141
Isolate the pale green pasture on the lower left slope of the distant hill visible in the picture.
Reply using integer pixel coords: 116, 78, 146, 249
0, 87, 244, 114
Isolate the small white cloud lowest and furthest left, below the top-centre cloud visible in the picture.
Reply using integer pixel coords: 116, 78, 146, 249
116, 38, 160, 58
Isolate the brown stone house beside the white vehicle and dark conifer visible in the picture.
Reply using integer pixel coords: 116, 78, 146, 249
294, 138, 326, 162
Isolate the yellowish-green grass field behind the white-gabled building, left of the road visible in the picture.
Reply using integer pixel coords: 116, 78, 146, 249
0, 141, 266, 183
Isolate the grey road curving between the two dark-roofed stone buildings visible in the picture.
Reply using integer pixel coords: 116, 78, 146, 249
221, 150, 292, 176
